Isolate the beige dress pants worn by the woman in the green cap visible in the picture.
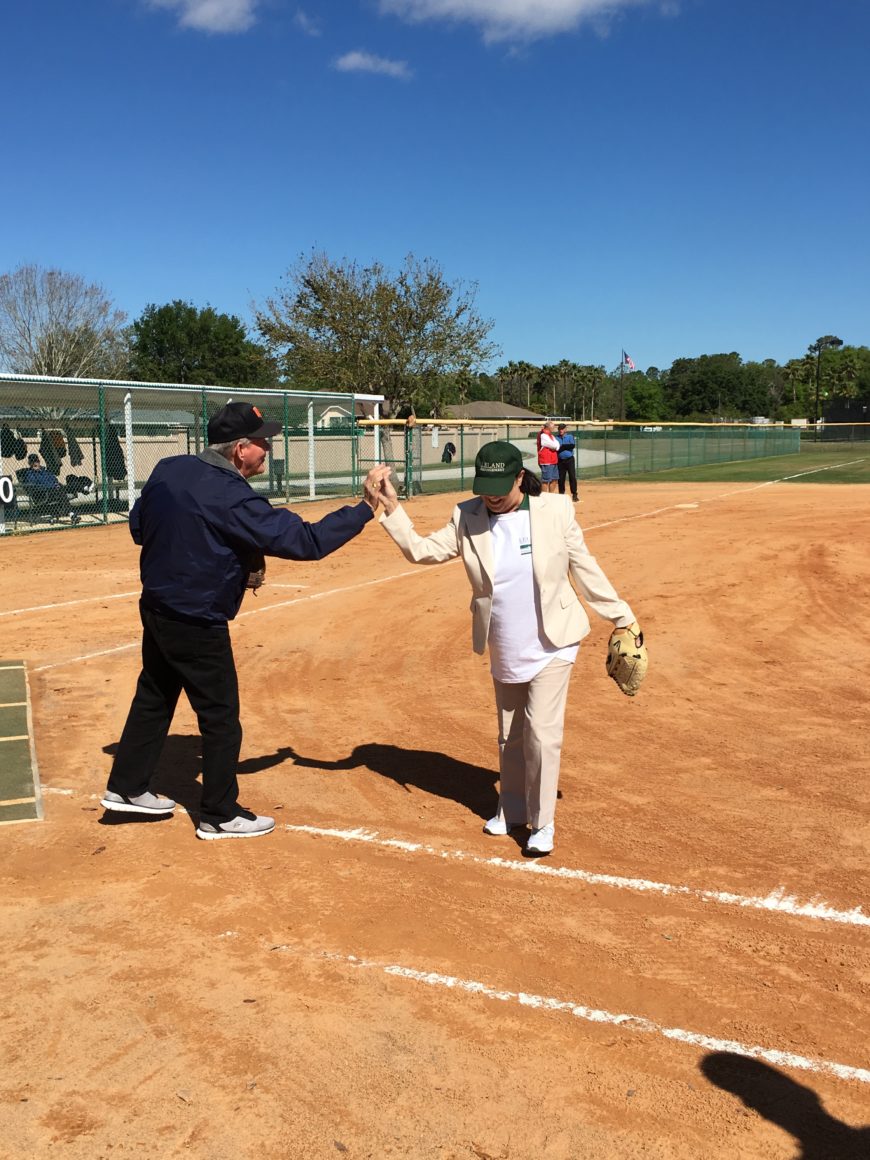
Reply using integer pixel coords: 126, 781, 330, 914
493, 660, 574, 829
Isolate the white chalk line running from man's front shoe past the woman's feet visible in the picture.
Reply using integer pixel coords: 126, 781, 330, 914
284, 824, 870, 927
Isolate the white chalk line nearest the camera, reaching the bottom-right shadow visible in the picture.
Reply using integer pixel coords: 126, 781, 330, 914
308, 947, 870, 1083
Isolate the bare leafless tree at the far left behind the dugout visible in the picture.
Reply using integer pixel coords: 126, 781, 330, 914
0, 264, 126, 378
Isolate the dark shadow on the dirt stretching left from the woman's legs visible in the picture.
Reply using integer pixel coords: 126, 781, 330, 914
282, 742, 499, 819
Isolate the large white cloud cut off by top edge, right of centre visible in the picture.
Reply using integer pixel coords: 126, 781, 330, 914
380, 0, 652, 41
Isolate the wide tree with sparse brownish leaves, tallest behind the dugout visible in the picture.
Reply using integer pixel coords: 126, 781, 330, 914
255, 251, 495, 414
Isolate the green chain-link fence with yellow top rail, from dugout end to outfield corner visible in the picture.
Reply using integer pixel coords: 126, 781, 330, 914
360, 420, 800, 496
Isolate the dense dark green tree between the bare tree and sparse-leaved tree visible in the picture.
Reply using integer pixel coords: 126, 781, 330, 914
129, 299, 277, 387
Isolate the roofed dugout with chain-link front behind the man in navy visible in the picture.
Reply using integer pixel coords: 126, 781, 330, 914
0, 375, 380, 534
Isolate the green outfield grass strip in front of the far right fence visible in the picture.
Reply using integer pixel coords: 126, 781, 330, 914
598, 443, 870, 484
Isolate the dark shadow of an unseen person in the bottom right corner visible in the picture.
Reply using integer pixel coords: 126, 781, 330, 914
701, 1051, 870, 1160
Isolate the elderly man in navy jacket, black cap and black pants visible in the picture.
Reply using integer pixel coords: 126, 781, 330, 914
101, 403, 389, 840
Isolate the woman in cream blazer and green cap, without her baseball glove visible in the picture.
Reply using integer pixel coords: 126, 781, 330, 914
379, 441, 640, 856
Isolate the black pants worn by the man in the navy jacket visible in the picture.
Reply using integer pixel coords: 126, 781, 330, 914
109, 608, 241, 821
